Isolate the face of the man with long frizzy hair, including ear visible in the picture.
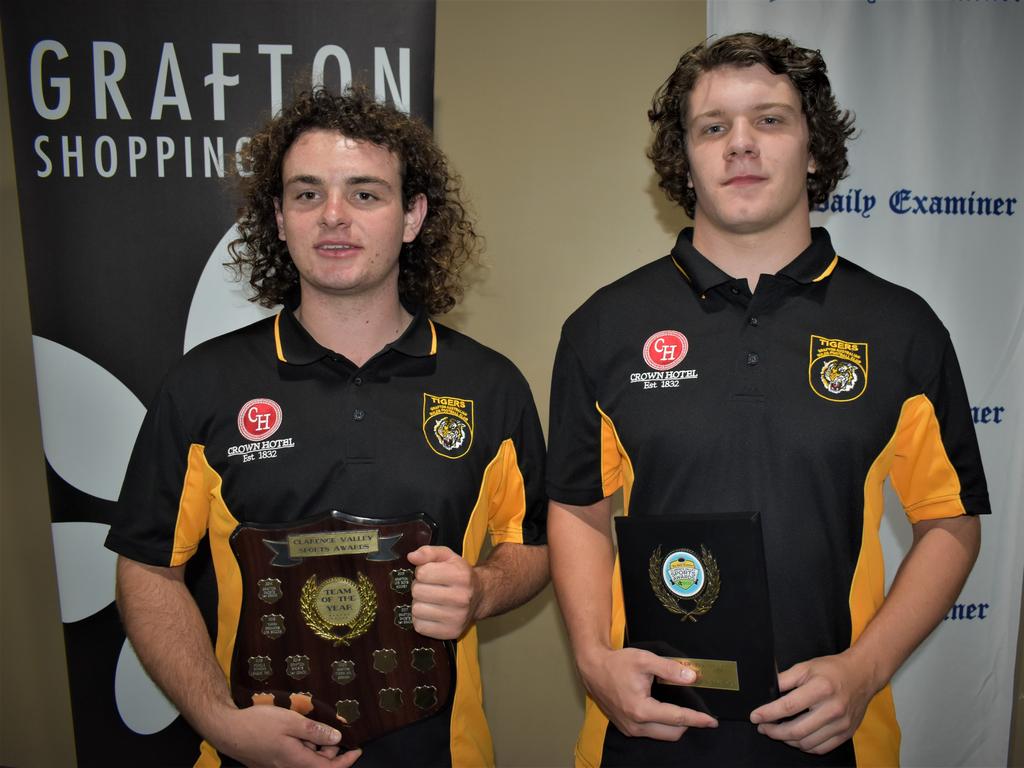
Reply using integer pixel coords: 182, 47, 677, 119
274, 129, 427, 301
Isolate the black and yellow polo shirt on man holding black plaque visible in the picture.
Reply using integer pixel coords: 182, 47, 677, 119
548, 229, 989, 766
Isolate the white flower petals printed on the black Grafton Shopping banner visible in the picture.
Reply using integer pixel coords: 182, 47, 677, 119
33, 226, 274, 734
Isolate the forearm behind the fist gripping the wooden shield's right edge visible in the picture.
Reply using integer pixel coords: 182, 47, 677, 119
474, 544, 549, 621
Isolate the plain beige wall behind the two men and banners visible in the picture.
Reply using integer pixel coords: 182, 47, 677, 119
0, 0, 1024, 768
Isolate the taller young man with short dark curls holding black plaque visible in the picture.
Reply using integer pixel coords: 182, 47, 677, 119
548, 34, 989, 766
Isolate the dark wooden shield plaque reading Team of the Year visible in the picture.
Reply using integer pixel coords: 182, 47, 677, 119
230, 511, 455, 748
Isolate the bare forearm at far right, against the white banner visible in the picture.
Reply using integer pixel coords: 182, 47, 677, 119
849, 515, 981, 690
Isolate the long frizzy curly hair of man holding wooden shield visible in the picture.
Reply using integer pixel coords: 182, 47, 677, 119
228, 86, 480, 314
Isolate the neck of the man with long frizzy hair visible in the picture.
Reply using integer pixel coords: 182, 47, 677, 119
295, 291, 413, 368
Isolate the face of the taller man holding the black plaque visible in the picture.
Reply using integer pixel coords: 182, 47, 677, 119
686, 65, 814, 234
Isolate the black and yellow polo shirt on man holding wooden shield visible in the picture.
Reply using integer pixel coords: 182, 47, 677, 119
106, 310, 546, 766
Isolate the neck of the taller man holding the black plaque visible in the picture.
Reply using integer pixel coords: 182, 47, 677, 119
693, 218, 811, 293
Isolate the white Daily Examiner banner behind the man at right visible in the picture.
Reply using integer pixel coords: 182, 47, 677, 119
708, 0, 1024, 766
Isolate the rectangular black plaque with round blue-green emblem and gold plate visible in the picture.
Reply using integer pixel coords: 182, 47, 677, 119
615, 512, 778, 721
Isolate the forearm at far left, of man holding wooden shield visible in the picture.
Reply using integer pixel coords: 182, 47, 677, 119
117, 557, 234, 740
